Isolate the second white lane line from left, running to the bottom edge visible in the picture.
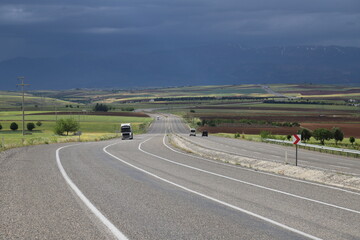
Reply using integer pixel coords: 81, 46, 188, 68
103, 142, 321, 240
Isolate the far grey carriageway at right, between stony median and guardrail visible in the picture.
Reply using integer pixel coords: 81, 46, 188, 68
168, 116, 360, 176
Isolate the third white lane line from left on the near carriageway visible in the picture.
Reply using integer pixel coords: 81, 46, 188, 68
138, 138, 360, 214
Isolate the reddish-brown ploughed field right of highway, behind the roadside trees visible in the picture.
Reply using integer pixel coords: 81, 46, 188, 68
192, 106, 360, 138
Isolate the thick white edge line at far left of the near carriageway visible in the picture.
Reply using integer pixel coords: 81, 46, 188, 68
56, 144, 128, 240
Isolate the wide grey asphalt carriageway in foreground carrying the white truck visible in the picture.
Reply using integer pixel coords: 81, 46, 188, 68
0, 116, 360, 240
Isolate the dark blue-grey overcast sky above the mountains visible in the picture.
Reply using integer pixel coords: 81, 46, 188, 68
0, 0, 360, 60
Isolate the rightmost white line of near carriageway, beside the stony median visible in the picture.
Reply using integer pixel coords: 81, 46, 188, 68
163, 132, 360, 196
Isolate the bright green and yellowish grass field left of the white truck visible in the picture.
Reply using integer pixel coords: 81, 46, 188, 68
0, 111, 152, 150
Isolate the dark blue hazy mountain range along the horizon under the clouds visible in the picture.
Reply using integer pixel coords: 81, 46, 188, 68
0, 44, 360, 90
